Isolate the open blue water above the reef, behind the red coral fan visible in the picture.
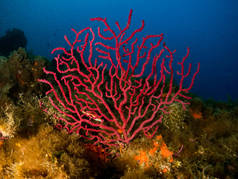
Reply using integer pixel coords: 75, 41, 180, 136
0, 0, 238, 101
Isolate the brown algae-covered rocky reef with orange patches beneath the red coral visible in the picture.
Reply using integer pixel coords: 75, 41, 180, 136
0, 48, 238, 179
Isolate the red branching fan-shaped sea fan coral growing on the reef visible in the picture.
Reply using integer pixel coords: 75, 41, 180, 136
39, 10, 200, 146
